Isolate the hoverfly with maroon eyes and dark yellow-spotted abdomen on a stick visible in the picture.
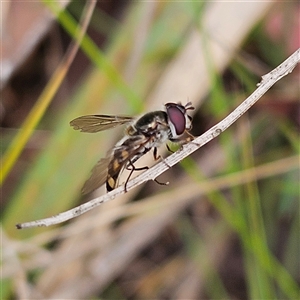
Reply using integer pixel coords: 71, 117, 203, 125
70, 102, 194, 194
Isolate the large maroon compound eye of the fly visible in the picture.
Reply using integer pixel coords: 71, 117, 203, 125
165, 103, 186, 136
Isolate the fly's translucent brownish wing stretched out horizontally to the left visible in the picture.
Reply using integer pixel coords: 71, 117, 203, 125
70, 115, 134, 133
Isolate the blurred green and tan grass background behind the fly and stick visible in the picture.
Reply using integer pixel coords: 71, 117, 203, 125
1, 1, 300, 299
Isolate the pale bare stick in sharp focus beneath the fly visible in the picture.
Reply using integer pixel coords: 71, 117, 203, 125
16, 49, 300, 229
